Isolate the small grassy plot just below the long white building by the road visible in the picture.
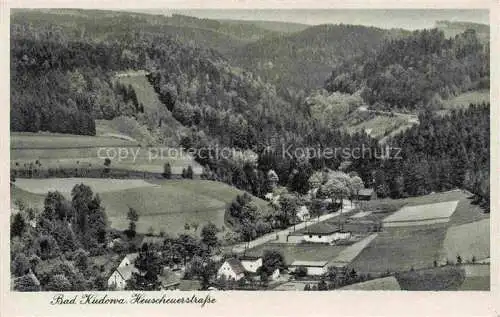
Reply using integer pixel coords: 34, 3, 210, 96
246, 243, 346, 265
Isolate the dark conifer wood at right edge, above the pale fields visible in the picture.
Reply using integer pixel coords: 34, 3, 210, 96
374, 104, 490, 207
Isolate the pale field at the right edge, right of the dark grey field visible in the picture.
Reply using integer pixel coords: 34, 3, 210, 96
443, 219, 490, 262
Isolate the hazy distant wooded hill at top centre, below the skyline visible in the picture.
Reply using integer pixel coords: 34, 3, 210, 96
233, 25, 399, 91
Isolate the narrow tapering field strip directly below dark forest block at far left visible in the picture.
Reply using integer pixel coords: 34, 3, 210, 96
10, 132, 137, 149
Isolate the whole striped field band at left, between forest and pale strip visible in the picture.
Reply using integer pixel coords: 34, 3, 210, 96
10, 133, 202, 177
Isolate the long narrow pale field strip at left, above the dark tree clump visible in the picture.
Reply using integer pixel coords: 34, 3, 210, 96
15, 178, 155, 195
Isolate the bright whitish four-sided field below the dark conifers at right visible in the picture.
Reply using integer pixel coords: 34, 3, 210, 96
383, 201, 458, 226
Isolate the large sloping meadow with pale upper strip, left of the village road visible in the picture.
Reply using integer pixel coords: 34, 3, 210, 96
11, 178, 267, 235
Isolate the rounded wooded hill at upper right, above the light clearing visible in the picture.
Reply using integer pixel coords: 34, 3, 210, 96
326, 29, 489, 111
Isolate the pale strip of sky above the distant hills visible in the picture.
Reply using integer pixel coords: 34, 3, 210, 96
133, 9, 489, 30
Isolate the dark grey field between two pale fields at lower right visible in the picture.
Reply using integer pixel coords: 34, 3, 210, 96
350, 225, 446, 273
